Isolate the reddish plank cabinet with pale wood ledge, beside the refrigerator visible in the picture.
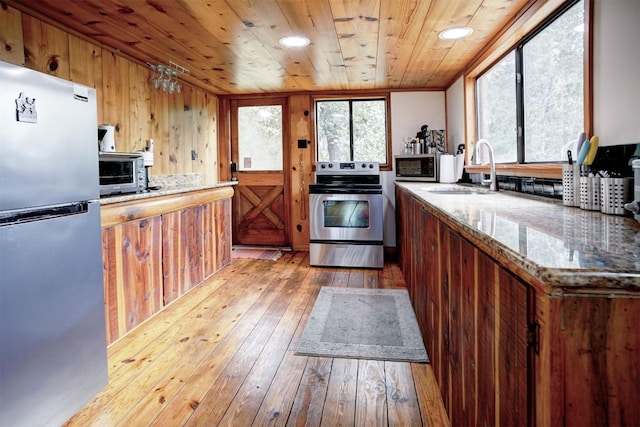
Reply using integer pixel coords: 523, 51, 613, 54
102, 187, 233, 343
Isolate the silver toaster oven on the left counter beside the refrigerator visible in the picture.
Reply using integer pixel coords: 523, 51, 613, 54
99, 152, 147, 196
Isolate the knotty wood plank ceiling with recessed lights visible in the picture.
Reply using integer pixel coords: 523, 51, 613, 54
7, 0, 528, 94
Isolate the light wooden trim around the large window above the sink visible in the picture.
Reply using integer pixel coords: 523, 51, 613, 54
464, 0, 594, 179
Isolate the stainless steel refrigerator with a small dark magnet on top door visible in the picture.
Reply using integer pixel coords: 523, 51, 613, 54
0, 61, 107, 426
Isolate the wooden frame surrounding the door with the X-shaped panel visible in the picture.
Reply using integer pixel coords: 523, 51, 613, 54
226, 97, 291, 247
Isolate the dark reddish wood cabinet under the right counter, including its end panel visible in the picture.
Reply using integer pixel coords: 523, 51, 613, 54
396, 188, 640, 426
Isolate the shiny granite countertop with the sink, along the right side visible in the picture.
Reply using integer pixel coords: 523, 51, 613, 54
396, 182, 640, 291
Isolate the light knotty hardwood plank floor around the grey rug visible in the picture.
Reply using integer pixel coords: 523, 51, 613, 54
67, 252, 448, 426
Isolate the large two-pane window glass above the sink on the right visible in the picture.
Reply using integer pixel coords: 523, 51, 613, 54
476, 0, 585, 163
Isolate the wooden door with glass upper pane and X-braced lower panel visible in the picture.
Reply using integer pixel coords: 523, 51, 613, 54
231, 98, 290, 246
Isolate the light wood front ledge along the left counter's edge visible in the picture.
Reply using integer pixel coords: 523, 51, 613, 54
100, 182, 236, 228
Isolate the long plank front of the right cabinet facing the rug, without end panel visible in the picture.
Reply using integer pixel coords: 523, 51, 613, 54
396, 192, 531, 425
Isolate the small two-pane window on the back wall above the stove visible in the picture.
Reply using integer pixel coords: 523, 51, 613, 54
315, 98, 388, 166
